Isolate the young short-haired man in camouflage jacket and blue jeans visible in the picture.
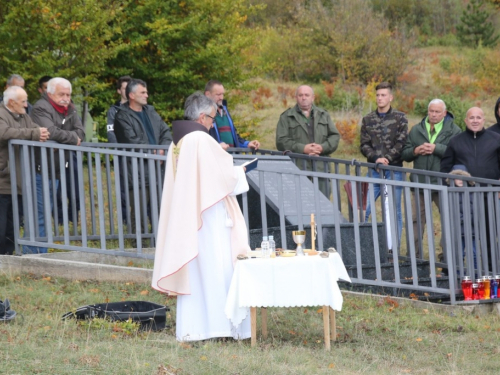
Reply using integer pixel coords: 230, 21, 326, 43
360, 82, 408, 247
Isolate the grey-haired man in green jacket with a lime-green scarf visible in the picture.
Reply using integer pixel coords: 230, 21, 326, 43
401, 99, 462, 257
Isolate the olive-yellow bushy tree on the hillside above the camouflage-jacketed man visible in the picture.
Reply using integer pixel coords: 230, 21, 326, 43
303, 0, 413, 82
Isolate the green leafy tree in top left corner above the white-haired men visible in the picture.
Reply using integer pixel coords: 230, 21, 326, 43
0, 0, 124, 104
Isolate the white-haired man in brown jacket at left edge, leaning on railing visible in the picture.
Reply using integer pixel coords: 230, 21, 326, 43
0, 86, 50, 254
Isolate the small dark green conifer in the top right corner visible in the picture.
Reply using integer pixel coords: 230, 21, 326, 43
457, 0, 499, 48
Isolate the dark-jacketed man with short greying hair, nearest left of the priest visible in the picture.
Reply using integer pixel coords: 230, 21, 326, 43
114, 79, 172, 226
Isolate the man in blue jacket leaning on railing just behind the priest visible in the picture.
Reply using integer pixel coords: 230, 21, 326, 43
205, 80, 260, 150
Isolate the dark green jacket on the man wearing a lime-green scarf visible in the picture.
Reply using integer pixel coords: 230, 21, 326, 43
402, 112, 462, 184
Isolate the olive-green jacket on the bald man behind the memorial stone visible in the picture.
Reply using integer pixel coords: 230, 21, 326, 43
276, 105, 340, 156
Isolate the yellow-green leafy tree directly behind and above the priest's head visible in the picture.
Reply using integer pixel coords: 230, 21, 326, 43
94, 0, 254, 121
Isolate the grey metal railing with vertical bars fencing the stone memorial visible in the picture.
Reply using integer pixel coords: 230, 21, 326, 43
9, 140, 500, 303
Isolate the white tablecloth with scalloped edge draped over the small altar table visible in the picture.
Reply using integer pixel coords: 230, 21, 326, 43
225, 253, 351, 326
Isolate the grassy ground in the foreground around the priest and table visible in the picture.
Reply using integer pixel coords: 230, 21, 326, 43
0, 274, 500, 375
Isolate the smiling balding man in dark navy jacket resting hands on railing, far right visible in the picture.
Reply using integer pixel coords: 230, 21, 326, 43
441, 107, 500, 270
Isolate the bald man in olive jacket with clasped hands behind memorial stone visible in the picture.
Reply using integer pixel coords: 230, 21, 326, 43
276, 85, 340, 197
